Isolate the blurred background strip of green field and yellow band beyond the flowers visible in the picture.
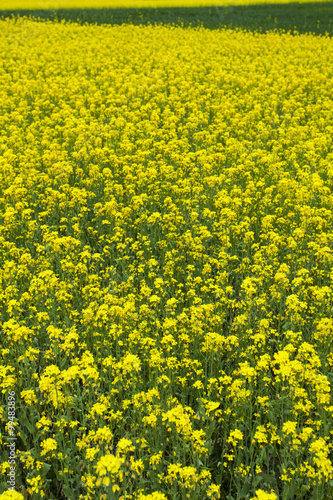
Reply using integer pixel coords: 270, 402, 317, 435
0, 0, 333, 35
